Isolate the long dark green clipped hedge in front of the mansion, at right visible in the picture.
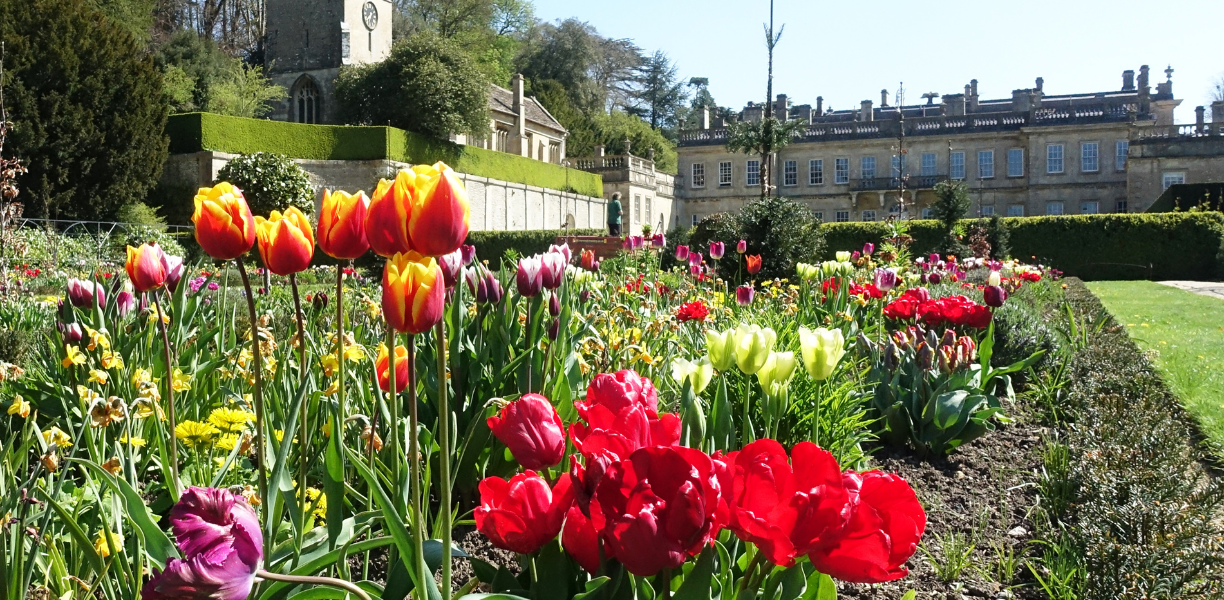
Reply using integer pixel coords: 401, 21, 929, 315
821, 212, 1224, 280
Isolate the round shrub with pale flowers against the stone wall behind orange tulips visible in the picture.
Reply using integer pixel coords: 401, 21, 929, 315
217, 152, 315, 217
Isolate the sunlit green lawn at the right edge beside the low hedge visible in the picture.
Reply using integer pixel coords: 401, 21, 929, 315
1088, 282, 1224, 447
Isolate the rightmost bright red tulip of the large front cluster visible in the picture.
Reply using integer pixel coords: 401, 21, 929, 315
809, 471, 927, 583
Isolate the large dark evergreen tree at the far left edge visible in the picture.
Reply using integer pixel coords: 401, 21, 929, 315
0, 0, 169, 219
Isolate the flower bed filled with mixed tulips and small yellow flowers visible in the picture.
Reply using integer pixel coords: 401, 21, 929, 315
7, 164, 1204, 600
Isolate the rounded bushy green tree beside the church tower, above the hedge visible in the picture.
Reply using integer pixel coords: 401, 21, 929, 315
335, 32, 490, 140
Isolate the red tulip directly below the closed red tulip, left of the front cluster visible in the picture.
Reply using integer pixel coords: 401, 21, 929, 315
474, 470, 574, 555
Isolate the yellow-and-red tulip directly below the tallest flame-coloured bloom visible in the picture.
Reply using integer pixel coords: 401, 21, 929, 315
382, 252, 446, 333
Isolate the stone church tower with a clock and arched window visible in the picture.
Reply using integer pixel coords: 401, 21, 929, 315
264, 0, 392, 124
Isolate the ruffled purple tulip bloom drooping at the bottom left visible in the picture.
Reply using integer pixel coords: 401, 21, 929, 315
141, 487, 263, 600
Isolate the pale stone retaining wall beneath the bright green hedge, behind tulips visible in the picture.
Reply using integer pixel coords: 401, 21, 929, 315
162, 151, 607, 231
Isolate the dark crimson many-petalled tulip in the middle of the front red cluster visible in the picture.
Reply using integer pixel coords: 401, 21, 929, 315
591, 447, 721, 577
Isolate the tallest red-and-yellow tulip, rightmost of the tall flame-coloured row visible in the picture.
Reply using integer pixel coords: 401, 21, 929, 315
408, 162, 471, 256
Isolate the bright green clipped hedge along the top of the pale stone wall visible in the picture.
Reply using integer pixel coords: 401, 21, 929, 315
165, 113, 603, 197
